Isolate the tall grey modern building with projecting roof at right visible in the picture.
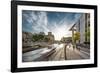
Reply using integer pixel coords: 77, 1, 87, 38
70, 13, 90, 43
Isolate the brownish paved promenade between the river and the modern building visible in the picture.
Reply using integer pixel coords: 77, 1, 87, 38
48, 44, 90, 61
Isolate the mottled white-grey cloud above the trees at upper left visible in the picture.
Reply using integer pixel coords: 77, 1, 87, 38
23, 11, 49, 33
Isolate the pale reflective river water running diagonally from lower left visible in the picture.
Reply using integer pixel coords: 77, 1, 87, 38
22, 44, 63, 62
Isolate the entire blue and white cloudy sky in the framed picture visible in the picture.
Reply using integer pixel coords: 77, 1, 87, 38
22, 10, 82, 40
